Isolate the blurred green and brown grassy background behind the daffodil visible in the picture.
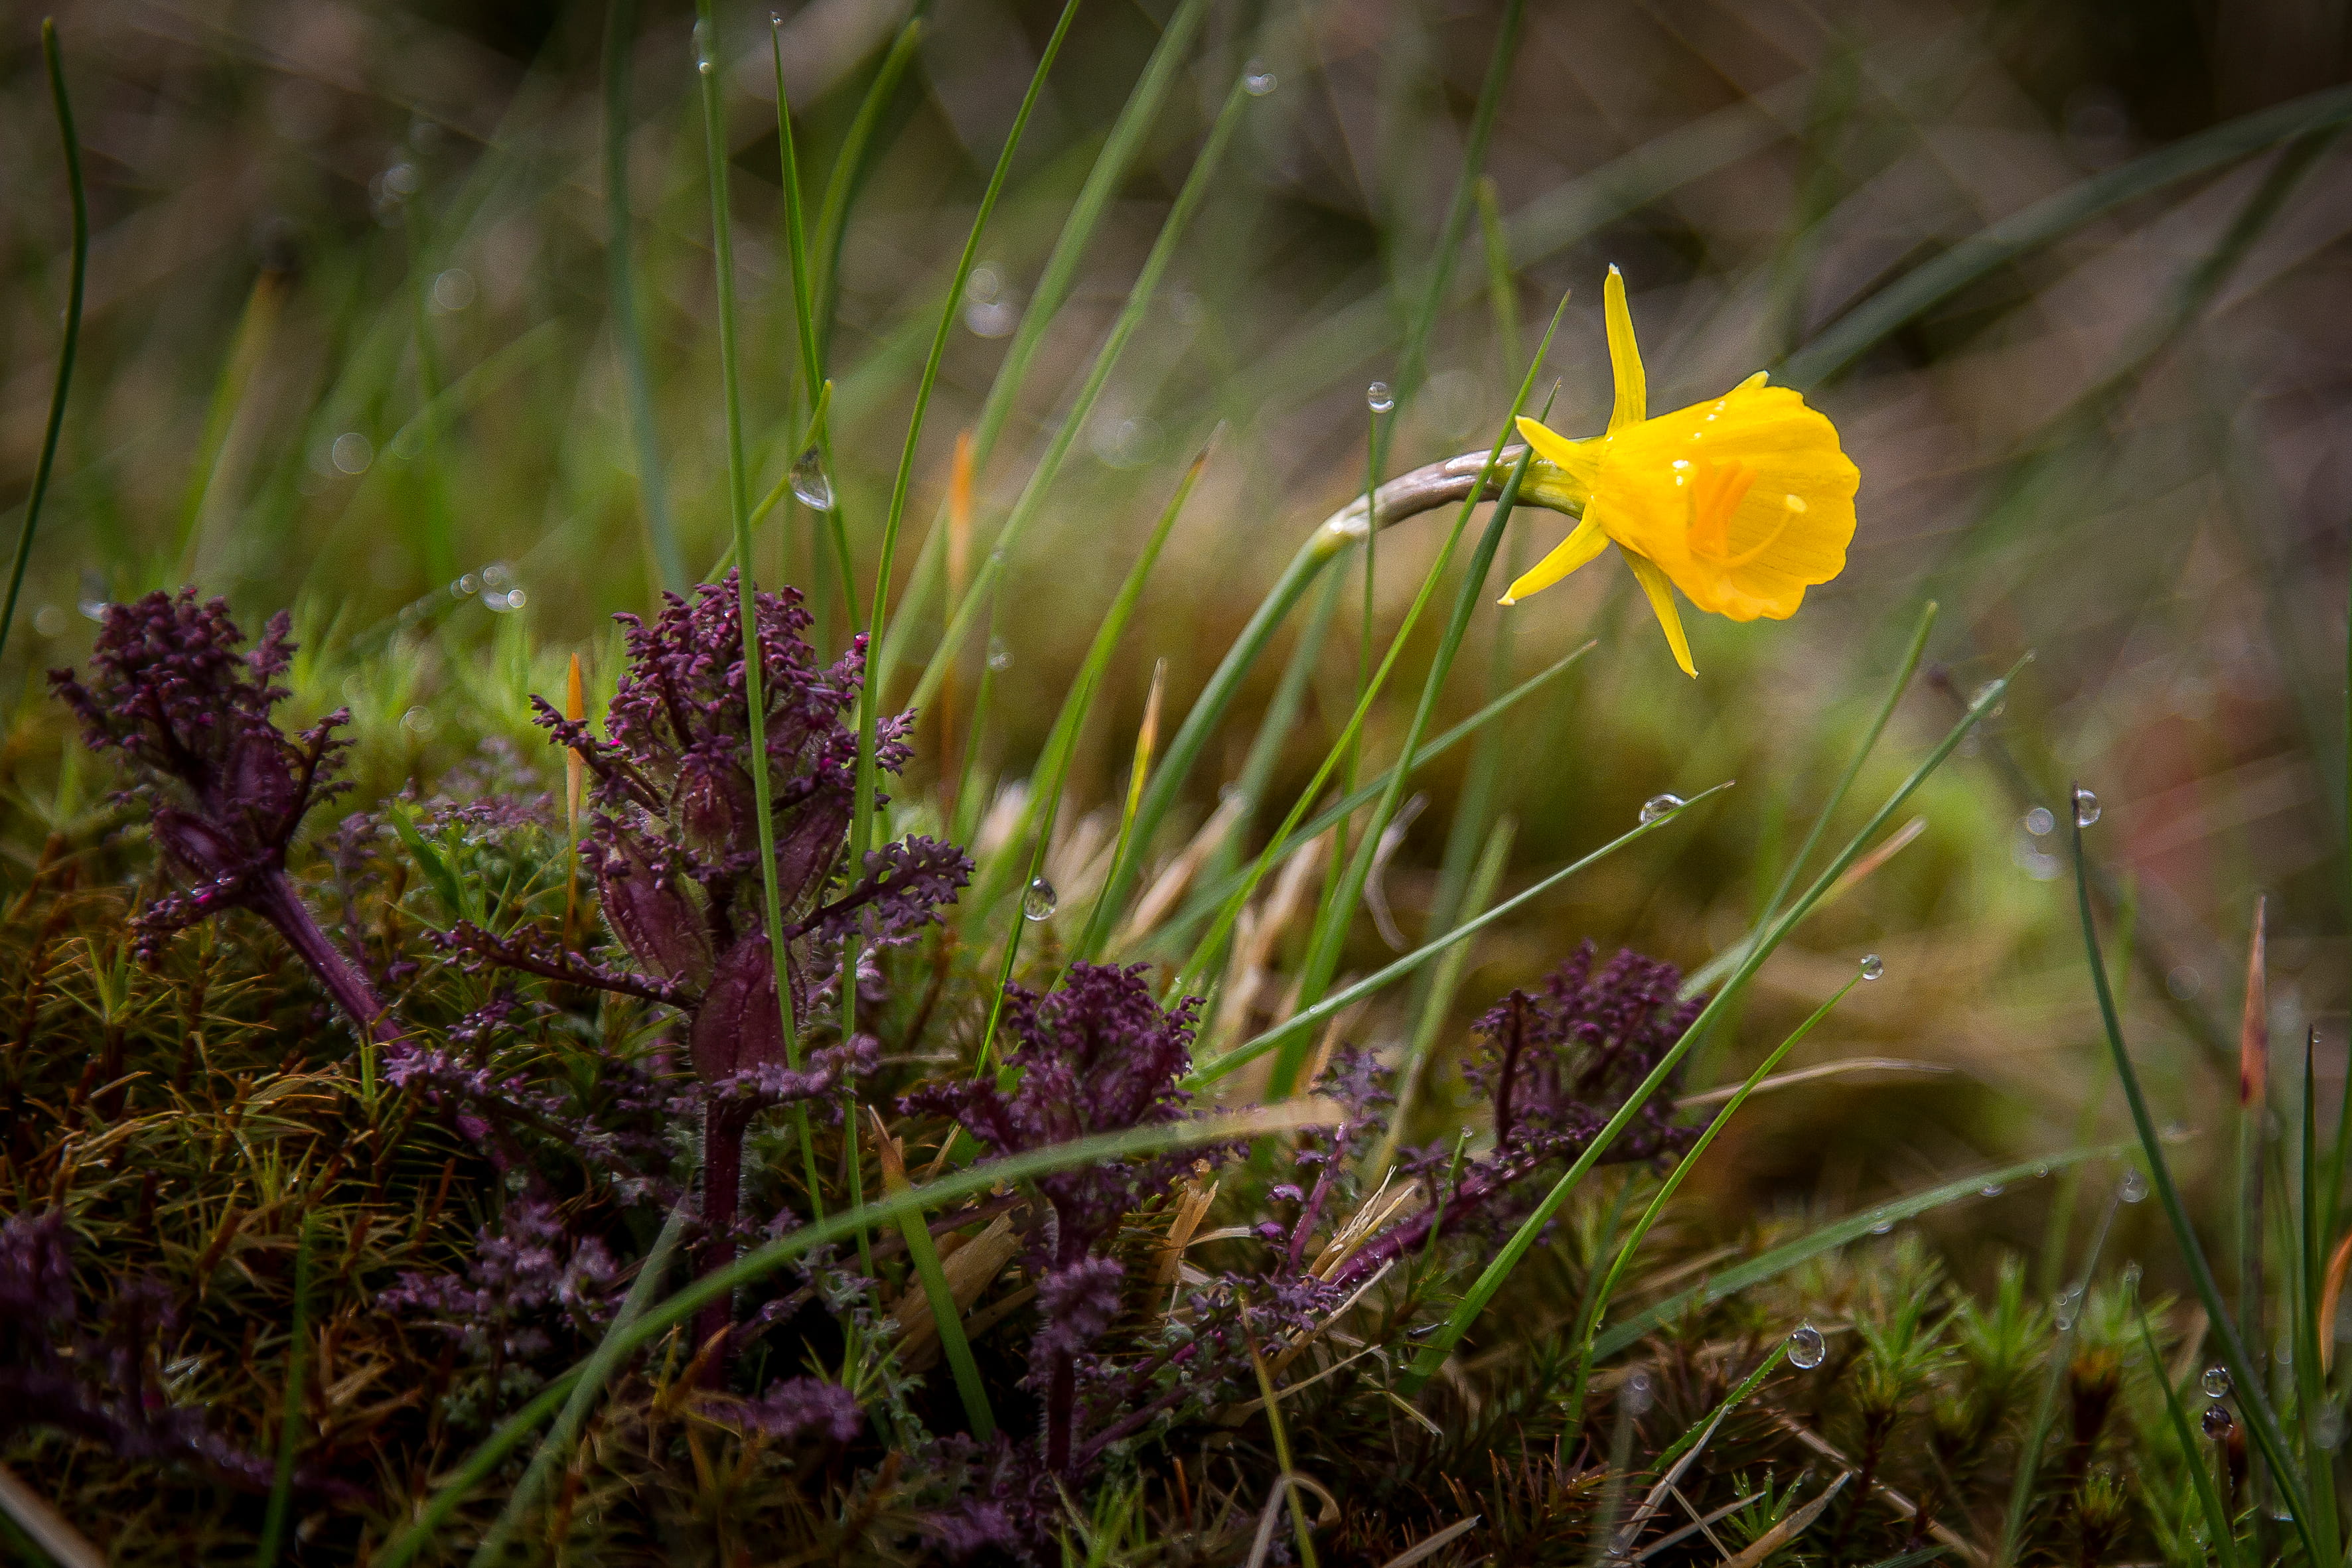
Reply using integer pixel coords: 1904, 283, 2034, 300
0, 0, 2352, 1288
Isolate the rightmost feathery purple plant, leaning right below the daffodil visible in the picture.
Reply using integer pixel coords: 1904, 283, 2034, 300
1333, 943, 1705, 1283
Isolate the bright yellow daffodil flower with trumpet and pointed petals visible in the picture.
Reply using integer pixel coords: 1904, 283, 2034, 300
1503, 268, 1860, 677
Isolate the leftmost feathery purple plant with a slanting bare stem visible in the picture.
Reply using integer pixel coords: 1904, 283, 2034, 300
49, 588, 395, 1039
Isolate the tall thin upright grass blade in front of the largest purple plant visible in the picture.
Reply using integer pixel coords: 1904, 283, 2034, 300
694, 0, 823, 1218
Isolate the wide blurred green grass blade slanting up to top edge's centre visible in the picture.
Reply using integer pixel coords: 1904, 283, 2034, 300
873, 0, 1207, 691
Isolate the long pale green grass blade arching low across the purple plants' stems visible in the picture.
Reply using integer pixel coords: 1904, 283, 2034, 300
372, 1100, 1345, 1568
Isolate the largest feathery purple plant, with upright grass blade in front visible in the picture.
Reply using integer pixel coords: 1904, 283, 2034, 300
449, 573, 972, 1338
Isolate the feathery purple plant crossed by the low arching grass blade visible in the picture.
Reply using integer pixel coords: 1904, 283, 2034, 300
901, 964, 1199, 1476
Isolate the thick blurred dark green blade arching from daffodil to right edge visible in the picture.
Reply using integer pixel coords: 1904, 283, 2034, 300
1781, 87, 2352, 388
